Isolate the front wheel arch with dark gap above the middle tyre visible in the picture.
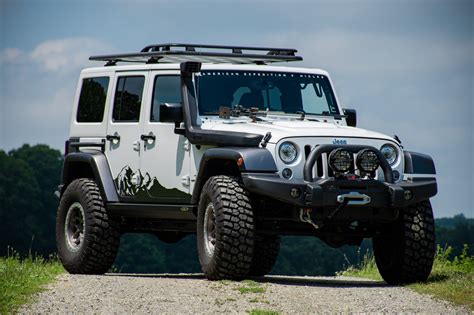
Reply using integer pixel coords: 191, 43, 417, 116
191, 147, 278, 204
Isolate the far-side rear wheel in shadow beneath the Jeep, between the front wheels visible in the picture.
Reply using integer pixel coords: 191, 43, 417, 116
249, 235, 281, 277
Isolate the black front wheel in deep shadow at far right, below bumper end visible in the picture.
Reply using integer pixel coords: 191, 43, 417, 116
373, 200, 436, 285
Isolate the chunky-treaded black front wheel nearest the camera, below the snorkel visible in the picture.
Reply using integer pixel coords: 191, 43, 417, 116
197, 176, 255, 280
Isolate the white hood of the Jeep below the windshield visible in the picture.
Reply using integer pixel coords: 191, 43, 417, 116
201, 120, 394, 143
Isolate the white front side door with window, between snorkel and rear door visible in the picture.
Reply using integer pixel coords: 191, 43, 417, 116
140, 71, 191, 204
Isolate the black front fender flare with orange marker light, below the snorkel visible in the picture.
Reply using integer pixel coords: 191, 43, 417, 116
192, 147, 278, 204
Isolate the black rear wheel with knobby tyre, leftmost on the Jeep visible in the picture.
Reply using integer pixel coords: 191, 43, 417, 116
56, 178, 120, 274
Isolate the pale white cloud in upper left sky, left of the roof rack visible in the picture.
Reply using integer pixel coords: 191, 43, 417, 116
0, 37, 112, 73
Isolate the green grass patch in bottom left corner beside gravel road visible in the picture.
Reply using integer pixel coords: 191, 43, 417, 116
0, 253, 64, 314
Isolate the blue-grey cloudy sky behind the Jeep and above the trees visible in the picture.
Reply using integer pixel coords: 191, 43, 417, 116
0, 0, 474, 217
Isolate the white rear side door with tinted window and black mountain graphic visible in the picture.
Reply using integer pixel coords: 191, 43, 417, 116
105, 72, 147, 200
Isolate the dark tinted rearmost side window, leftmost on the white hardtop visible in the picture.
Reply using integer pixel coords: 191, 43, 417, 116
76, 77, 109, 122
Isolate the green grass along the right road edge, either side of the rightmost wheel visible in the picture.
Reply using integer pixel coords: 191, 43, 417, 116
339, 245, 474, 311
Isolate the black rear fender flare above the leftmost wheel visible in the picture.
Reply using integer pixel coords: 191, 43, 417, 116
61, 150, 119, 202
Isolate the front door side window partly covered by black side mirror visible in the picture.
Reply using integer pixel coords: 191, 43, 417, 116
150, 75, 181, 122
